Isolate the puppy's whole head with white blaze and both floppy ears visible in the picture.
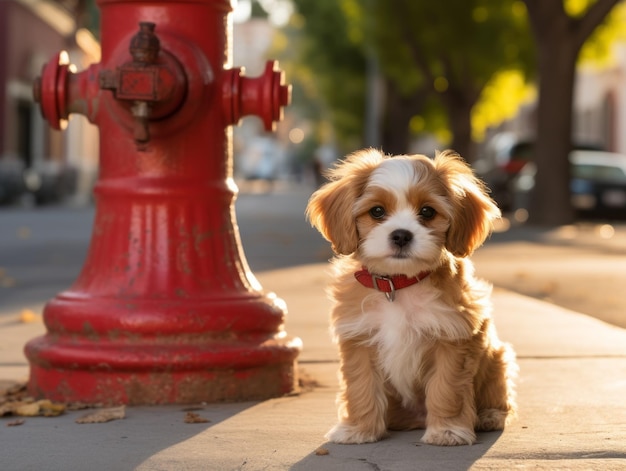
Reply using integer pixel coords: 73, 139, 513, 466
307, 149, 500, 276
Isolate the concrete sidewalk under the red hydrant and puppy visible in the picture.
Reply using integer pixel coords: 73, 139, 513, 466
0, 264, 626, 471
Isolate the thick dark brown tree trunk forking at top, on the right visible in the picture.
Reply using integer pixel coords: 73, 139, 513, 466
524, 0, 619, 225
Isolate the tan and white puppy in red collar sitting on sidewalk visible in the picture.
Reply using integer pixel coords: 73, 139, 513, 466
307, 149, 517, 445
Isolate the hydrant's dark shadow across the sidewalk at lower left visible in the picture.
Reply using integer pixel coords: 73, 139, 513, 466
2, 402, 259, 471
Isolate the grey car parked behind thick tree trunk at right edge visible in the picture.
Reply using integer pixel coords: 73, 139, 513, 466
513, 150, 626, 219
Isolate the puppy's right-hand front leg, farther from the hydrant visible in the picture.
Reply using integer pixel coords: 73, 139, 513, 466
422, 344, 477, 445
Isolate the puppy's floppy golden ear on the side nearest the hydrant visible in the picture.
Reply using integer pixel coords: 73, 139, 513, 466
306, 149, 383, 255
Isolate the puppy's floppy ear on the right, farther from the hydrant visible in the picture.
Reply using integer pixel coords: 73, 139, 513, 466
434, 151, 500, 257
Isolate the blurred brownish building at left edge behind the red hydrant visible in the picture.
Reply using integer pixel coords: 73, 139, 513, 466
0, 0, 97, 203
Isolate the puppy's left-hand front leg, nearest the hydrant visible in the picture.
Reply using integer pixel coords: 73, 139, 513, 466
326, 340, 387, 443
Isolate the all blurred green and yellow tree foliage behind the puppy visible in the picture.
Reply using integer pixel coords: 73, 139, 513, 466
287, 0, 626, 149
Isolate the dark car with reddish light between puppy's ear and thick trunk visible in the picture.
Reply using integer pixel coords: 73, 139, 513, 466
474, 133, 604, 212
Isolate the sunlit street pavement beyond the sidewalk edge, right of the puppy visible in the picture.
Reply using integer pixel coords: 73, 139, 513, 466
474, 216, 626, 327
